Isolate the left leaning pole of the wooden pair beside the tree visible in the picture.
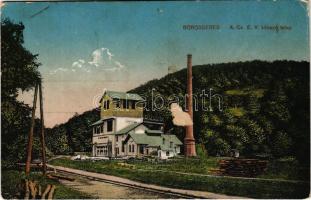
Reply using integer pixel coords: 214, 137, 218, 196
25, 85, 38, 176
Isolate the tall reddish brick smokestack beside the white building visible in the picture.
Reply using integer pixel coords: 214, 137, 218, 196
184, 54, 196, 156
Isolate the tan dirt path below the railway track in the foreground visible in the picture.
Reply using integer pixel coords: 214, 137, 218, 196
60, 173, 178, 199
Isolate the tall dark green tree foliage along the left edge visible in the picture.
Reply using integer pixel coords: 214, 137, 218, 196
1, 19, 41, 168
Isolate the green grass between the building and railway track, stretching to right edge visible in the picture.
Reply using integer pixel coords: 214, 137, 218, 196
51, 158, 310, 198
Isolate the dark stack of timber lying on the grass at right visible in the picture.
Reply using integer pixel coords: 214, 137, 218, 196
211, 158, 268, 177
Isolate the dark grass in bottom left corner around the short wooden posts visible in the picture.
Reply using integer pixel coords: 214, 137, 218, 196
1, 170, 92, 199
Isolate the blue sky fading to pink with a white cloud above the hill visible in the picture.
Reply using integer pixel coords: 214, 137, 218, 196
1, 0, 309, 127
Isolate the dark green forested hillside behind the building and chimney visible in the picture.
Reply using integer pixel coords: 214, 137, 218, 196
48, 61, 310, 162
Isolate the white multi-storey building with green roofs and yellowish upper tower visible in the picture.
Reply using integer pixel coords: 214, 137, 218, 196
92, 91, 182, 159
